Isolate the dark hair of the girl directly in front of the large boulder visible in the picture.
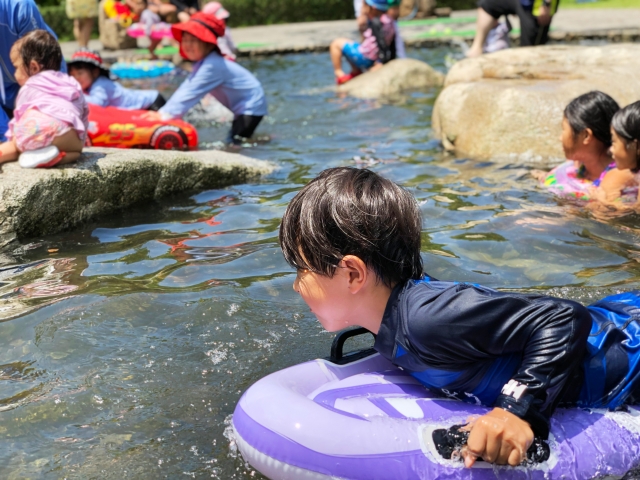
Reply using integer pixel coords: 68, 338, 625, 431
564, 90, 620, 147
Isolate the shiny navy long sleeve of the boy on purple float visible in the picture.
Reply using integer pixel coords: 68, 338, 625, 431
381, 282, 591, 438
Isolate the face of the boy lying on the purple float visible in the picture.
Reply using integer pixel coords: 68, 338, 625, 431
293, 267, 353, 332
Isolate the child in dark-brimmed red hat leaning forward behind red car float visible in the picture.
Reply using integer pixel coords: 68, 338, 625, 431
67, 48, 166, 111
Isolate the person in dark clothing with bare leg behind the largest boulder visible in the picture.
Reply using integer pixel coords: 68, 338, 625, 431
467, 0, 560, 57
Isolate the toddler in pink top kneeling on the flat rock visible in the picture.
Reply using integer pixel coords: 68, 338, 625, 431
0, 30, 89, 168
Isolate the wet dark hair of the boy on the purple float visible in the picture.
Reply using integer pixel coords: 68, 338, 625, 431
280, 167, 422, 287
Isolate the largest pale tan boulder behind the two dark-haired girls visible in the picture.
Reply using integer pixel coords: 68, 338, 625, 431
433, 44, 640, 158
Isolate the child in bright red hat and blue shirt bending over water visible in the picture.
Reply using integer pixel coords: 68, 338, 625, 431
146, 12, 267, 144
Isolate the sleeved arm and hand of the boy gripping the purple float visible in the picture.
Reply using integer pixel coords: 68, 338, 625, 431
406, 284, 591, 467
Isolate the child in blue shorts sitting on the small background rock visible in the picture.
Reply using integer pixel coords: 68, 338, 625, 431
329, 0, 396, 85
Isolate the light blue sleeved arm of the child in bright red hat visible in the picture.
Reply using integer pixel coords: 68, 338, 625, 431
158, 59, 223, 118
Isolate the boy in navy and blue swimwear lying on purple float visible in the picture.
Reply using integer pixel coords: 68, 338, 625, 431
280, 168, 640, 467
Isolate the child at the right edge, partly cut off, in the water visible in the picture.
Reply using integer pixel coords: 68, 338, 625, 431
593, 101, 640, 210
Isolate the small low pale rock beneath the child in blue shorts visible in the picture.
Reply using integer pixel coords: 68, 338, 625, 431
338, 58, 444, 98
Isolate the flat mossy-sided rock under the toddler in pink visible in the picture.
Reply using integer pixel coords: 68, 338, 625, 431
0, 148, 274, 251
